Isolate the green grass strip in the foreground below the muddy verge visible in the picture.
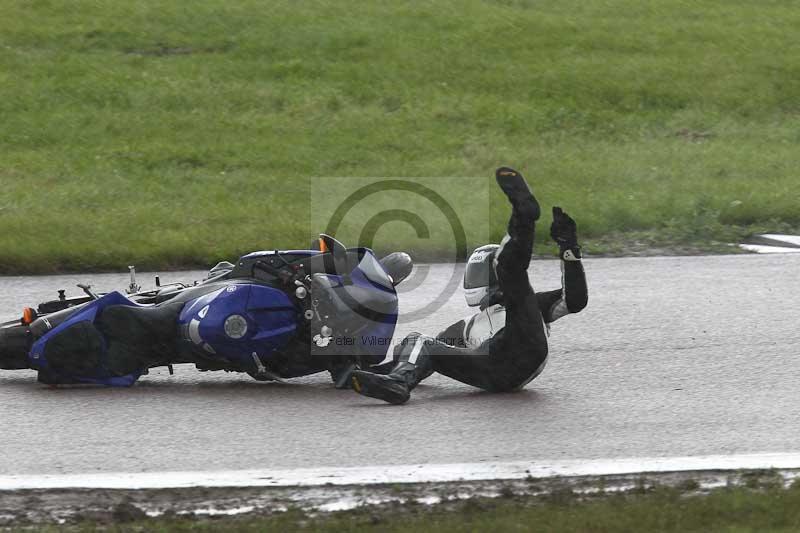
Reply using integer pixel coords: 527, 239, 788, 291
31, 488, 800, 533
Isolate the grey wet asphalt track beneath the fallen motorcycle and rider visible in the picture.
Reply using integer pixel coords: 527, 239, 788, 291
0, 254, 800, 475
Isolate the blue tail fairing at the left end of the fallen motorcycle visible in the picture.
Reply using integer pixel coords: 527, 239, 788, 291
28, 291, 146, 387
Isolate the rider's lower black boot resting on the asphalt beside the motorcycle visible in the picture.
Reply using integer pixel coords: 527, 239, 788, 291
351, 334, 433, 405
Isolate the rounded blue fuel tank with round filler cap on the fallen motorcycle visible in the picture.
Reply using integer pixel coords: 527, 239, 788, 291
178, 283, 297, 361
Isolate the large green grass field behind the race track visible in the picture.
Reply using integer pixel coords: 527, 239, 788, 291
0, 0, 800, 272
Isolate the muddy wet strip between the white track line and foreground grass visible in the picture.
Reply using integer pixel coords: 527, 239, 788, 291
0, 470, 800, 527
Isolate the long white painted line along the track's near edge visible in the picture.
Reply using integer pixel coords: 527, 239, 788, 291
0, 453, 800, 490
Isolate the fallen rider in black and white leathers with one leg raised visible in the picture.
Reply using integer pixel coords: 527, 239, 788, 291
351, 167, 587, 404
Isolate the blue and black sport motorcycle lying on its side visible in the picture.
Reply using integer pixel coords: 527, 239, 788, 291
0, 234, 413, 386
